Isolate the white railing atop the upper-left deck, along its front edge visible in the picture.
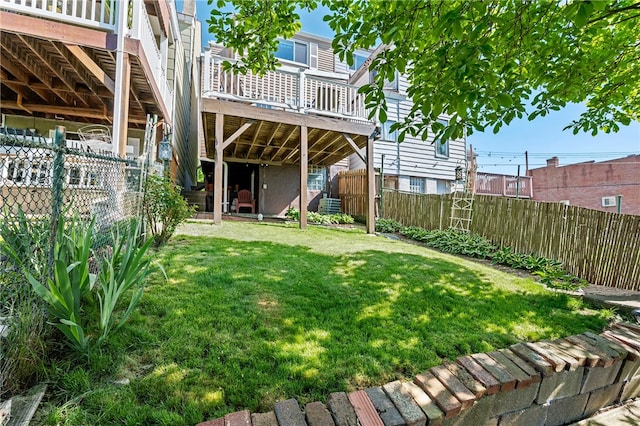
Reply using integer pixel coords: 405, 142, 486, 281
0, 0, 116, 32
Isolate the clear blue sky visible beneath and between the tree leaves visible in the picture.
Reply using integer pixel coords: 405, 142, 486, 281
184, 0, 640, 175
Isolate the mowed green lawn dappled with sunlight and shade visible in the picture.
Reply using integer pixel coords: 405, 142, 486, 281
41, 222, 606, 425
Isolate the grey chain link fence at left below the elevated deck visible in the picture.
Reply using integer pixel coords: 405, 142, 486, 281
0, 128, 150, 399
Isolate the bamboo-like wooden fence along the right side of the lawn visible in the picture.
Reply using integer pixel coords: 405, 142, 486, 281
380, 190, 640, 291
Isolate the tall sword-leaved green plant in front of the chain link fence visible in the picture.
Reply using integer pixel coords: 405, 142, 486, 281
25, 217, 157, 354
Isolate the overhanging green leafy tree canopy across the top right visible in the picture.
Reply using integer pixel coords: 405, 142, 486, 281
207, 0, 640, 140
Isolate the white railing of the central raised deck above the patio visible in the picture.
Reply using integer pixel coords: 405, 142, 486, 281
202, 52, 369, 121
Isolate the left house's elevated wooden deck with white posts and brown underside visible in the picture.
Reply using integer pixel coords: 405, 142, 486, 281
0, 0, 200, 185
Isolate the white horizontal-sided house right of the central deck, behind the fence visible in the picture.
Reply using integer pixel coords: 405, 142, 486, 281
344, 51, 467, 194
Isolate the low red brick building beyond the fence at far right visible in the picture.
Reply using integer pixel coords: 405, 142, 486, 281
527, 155, 640, 215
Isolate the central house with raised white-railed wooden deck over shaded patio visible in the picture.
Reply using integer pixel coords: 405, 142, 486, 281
200, 33, 375, 230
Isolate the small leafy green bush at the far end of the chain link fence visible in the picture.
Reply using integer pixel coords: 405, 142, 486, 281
143, 175, 196, 247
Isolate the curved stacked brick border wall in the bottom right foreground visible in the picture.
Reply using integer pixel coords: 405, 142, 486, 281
197, 323, 640, 426
